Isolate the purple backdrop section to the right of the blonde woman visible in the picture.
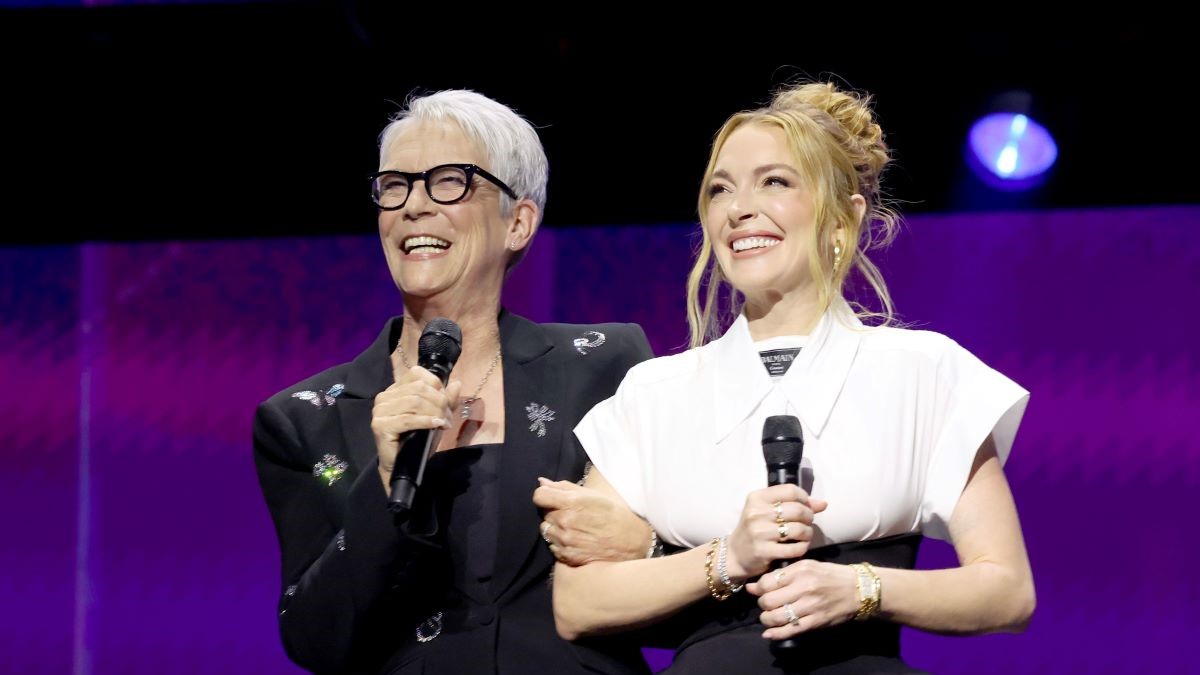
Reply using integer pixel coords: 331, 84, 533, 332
886, 208, 1200, 674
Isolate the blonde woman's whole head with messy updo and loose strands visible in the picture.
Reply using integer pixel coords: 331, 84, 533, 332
688, 83, 898, 347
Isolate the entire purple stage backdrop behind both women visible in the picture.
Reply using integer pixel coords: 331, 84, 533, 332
0, 207, 1200, 674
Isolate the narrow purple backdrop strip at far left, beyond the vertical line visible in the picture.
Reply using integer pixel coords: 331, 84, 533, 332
0, 246, 79, 673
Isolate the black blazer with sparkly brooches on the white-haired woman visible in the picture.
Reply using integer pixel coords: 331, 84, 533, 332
254, 311, 652, 673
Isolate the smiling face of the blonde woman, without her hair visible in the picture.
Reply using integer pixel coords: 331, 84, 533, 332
704, 124, 816, 297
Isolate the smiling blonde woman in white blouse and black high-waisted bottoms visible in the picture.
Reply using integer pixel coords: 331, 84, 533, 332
536, 84, 1034, 674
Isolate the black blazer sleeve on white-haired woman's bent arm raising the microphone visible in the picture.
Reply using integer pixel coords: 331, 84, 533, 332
253, 401, 438, 673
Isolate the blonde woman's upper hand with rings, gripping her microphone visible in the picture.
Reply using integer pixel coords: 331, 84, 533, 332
726, 485, 829, 584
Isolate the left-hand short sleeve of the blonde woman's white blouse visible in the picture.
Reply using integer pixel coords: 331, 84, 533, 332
575, 366, 646, 518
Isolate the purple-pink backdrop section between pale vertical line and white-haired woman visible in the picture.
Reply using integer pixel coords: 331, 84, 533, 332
86, 237, 400, 673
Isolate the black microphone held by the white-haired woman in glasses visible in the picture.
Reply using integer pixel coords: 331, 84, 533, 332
388, 318, 462, 515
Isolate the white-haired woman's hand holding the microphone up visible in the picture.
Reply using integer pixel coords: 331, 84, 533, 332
371, 365, 461, 490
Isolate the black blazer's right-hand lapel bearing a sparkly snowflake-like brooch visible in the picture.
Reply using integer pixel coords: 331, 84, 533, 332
492, 311, 569, 598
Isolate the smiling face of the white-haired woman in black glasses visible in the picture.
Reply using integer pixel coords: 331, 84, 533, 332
379, 123, 512, 299
